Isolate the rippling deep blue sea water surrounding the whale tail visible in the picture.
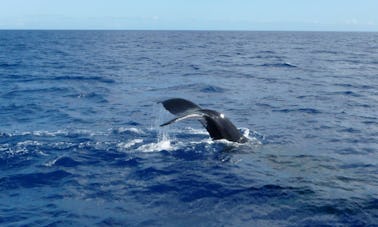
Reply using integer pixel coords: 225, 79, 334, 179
0, 31, 378, 226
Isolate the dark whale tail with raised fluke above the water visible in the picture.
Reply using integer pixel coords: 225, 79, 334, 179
160, 98, 248, 143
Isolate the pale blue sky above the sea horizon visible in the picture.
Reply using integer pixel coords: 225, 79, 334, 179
0, 0, 378, 31
